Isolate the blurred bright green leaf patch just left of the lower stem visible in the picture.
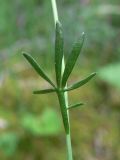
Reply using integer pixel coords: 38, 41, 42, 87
21, 109, 61, 136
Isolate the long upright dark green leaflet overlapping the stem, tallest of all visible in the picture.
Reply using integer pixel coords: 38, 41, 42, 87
55, 22, 64, 86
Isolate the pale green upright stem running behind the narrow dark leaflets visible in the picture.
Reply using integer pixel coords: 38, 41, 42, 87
51, 0, 73, 160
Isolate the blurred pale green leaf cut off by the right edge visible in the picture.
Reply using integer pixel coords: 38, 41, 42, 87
99, 63, 120, 88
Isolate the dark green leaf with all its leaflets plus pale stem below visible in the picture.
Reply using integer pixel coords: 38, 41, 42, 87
23, 0, 96, 160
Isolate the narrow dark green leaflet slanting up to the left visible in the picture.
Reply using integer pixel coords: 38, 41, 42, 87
23, 53, 55, 88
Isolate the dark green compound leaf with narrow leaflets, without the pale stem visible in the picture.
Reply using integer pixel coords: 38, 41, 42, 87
23, 22, 96, 129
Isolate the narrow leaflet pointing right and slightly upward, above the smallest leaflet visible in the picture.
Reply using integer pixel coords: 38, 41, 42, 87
64, 73, 96, 91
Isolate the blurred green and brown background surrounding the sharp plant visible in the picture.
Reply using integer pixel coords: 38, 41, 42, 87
0, 0, 120, 160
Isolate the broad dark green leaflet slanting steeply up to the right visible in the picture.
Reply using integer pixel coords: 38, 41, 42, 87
62, 33, 85, 87
